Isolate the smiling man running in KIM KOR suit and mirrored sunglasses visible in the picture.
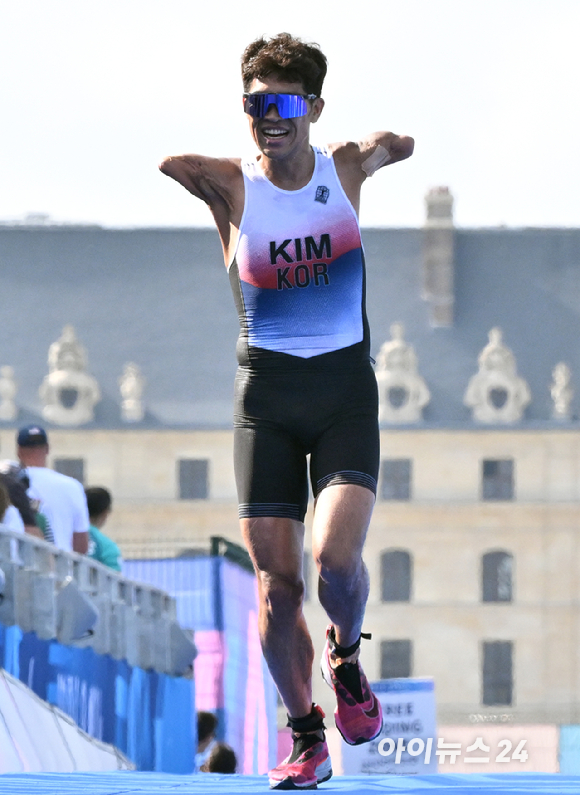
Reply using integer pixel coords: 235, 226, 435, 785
160, 33, 413, 789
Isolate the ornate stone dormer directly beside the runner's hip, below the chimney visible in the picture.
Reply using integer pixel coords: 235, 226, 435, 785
375, 323, 431, 424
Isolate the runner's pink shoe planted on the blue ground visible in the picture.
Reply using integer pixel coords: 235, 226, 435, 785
268, 706, 332, 789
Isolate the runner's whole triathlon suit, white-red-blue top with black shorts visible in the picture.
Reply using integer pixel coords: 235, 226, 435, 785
229, 147, 379, 521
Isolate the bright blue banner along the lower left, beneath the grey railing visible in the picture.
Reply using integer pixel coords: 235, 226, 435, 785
0, 624, 197, 773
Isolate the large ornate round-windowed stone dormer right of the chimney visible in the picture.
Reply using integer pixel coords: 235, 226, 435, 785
463, 328, 531, 424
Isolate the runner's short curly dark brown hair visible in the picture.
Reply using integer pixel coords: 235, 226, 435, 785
242, 33, 327, 97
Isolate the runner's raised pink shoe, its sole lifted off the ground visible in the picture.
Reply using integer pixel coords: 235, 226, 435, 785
320, 625, 383, 745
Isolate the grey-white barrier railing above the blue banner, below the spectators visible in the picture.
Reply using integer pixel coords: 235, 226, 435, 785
0, 525, 195, 676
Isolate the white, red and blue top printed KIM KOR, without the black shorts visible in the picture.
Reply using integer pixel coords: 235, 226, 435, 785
229, 147, 369, 364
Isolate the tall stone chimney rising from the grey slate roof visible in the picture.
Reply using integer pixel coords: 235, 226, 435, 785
423, 187, 454, 328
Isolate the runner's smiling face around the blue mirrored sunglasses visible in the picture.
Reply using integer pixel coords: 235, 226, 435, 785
247, 77, 324, 160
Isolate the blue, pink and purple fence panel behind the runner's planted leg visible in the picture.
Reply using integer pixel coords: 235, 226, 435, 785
123, 556, 277, 774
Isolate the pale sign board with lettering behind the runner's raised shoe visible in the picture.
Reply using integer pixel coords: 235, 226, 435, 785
342, 679, 438, 776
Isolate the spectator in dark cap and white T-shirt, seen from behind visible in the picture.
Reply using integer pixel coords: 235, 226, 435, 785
16, 425, 90, 555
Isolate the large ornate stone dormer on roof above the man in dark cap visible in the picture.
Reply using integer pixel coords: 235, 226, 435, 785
39, 326, 101, 425
